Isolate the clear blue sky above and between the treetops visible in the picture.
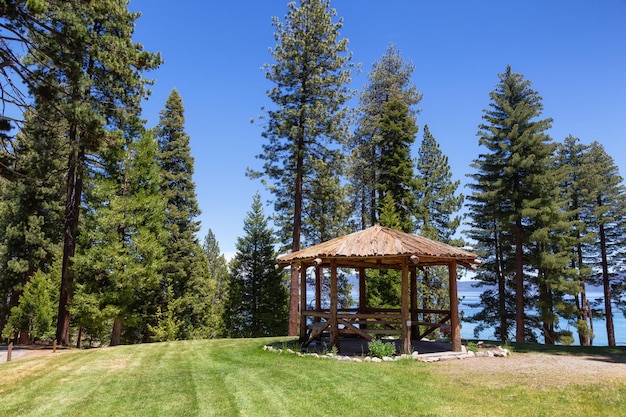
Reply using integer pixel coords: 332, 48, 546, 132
130, 0, 626, 256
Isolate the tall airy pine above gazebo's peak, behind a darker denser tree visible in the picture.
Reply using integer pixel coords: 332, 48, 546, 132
348, 44, 422, 229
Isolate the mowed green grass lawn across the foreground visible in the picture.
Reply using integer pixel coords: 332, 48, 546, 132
0, 339, 626, 417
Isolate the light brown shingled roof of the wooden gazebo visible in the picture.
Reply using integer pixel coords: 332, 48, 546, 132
278, 224, 481, 269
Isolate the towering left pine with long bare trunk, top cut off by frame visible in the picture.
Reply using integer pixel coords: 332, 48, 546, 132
22, 0, 160, 344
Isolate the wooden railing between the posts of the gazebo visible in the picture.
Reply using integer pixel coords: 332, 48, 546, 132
301, 308, 450, 345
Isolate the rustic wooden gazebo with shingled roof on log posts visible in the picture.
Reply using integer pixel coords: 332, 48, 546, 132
278, 225, 481, 353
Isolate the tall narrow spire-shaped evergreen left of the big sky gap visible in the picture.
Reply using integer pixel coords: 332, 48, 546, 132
155, 89, 208, 338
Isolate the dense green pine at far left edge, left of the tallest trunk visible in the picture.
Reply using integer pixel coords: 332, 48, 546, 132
0, 103, 67, 343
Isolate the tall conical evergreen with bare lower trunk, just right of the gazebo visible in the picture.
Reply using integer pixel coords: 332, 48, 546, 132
471, 66, 554, 341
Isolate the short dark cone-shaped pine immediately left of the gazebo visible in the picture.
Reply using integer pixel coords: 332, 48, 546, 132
224, 193, 288, 337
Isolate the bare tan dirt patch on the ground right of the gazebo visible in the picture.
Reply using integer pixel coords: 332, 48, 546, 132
432, 353, 626, 387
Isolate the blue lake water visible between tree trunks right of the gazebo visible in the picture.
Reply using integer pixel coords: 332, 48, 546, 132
459, 291, 626, 346
